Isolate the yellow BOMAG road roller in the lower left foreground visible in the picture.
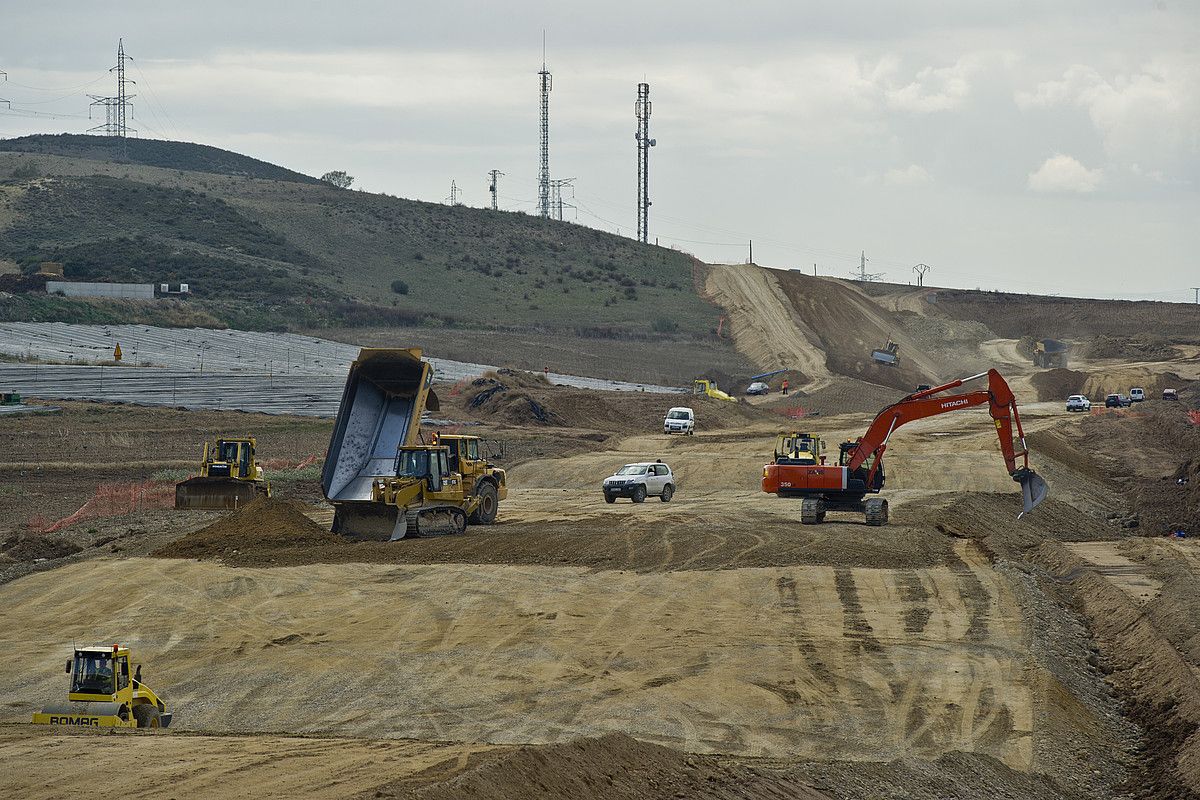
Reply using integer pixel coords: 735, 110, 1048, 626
32, 644, 172, 728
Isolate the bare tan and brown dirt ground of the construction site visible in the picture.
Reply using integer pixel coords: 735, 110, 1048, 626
0, 273, 1200, 800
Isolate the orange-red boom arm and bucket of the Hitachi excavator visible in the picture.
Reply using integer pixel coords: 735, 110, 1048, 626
846, 369, 1048, 513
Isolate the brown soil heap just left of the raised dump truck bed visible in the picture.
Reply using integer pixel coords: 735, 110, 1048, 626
151, 498, 346, 560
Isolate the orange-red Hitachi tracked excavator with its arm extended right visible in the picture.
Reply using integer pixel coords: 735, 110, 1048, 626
762, 369, 1048, 525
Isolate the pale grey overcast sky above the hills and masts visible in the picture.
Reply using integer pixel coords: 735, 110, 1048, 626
0, 0, 1200, 301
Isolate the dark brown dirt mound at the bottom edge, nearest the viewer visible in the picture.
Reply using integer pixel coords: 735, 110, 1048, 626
362, 733, 829, 800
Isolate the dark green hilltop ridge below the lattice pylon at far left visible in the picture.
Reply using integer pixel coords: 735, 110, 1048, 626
0, 133, 320, 184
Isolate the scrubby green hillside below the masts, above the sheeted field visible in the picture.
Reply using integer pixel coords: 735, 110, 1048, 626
0, 137, 719, 337
